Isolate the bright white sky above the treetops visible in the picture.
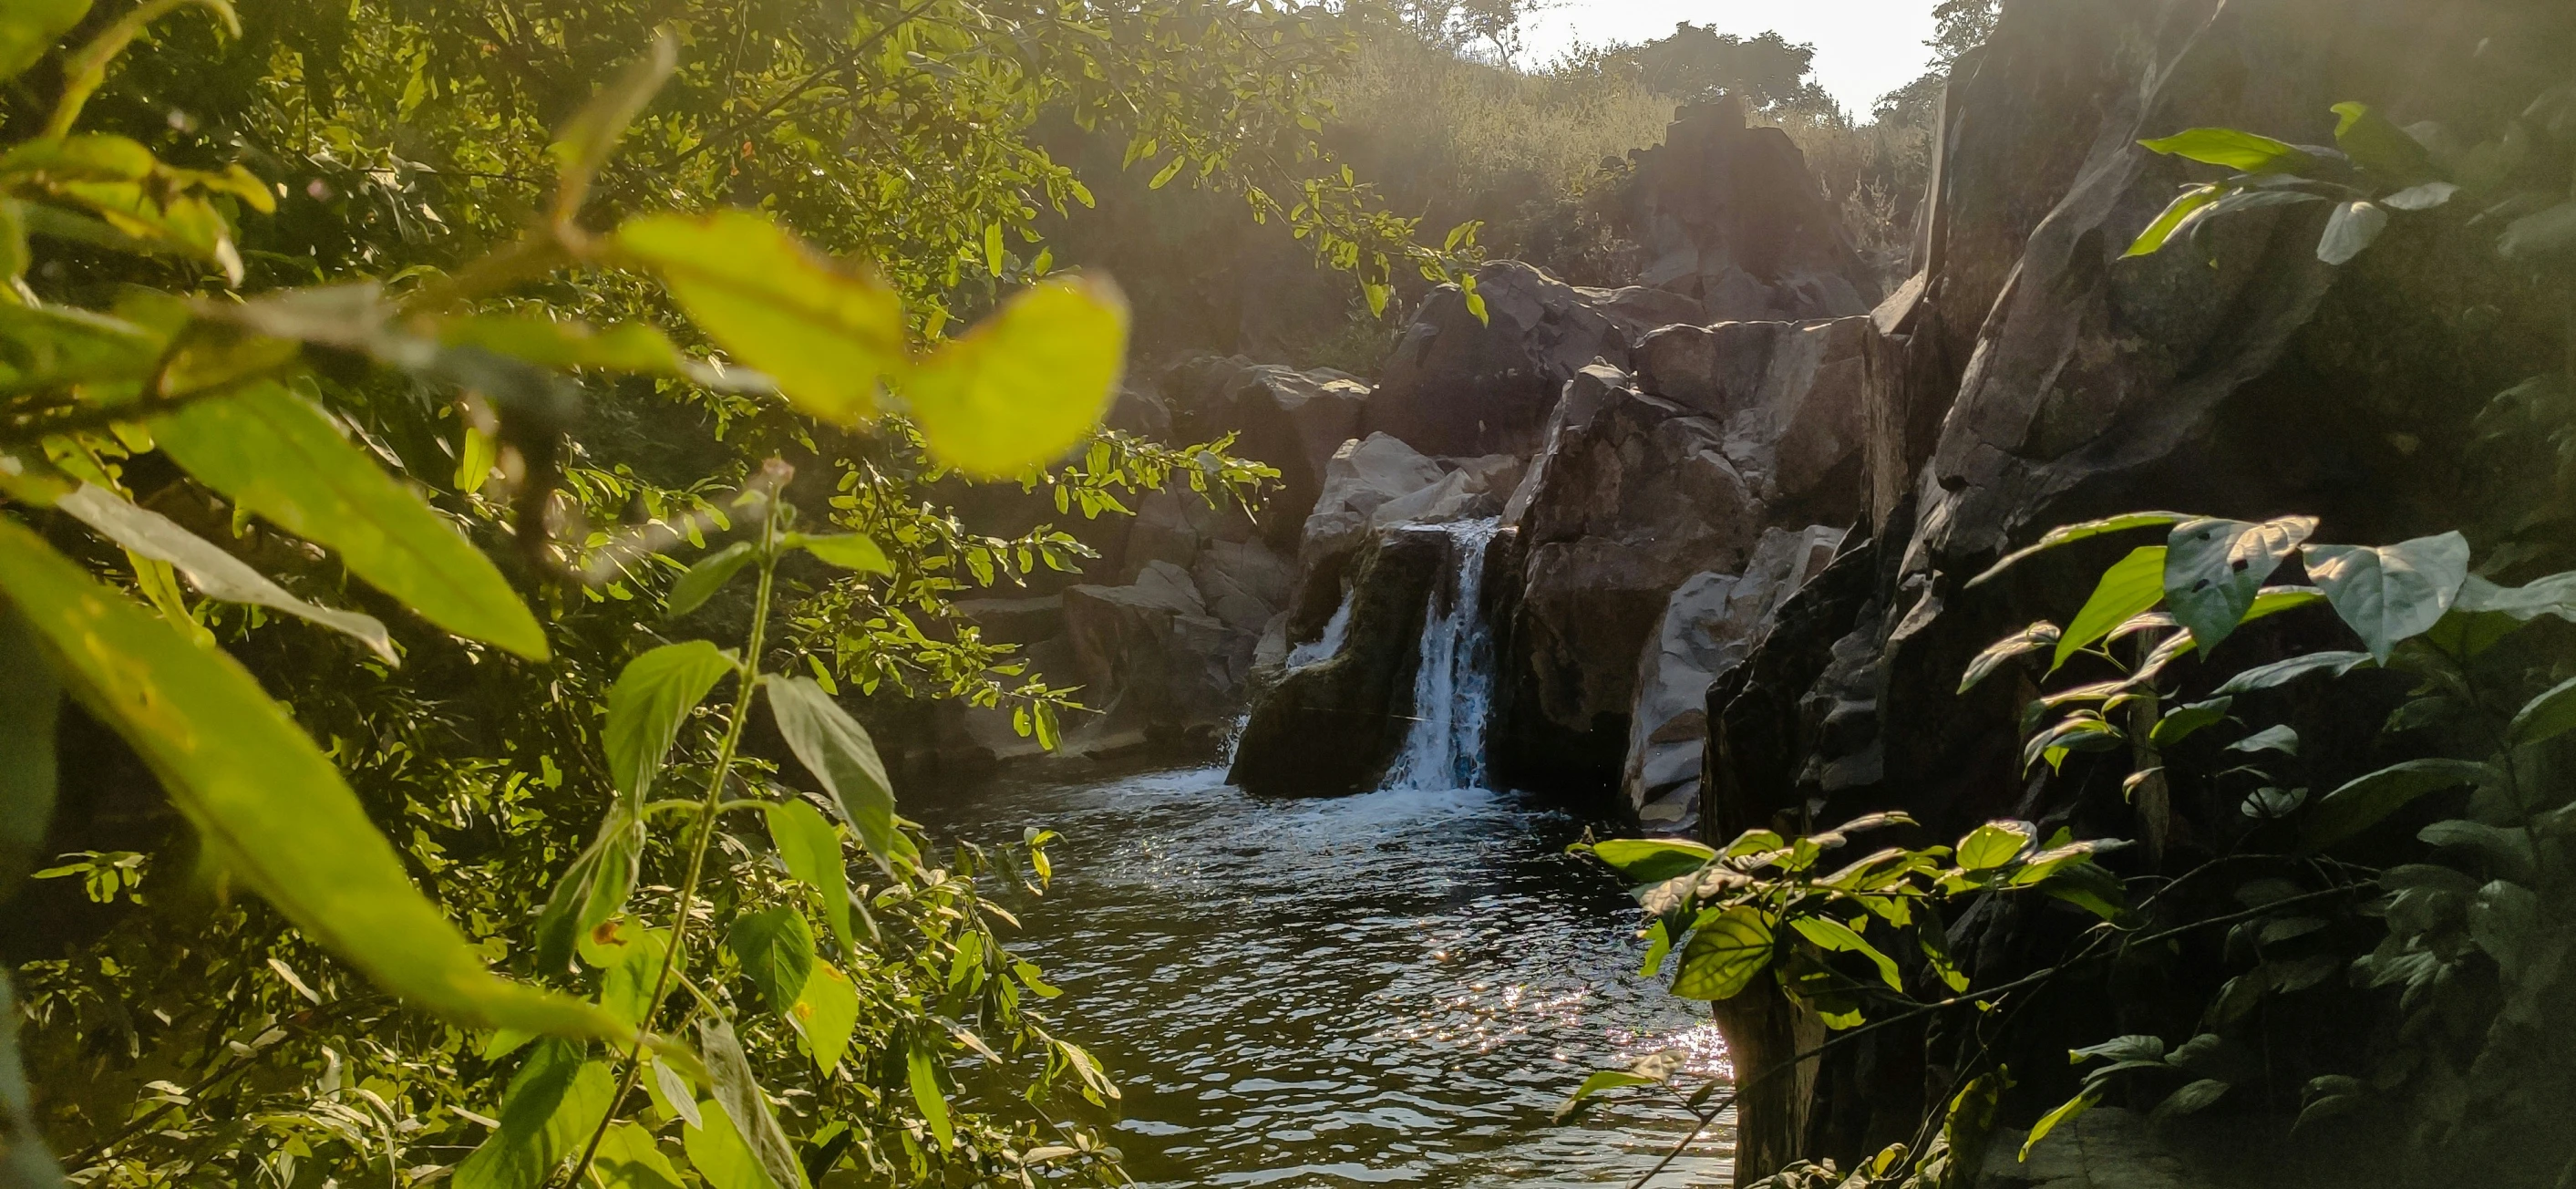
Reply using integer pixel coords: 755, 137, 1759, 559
1520, 0, 1934, 116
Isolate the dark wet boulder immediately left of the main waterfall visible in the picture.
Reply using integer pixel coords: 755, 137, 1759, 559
1226, 526, 1456, 797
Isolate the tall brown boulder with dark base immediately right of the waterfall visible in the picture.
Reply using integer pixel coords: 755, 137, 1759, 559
1494, 367, 1762, 784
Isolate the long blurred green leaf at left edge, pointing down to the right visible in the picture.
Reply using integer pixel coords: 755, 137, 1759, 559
0, 519, 634, 1039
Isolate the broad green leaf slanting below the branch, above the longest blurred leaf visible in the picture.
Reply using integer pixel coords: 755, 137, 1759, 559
152, 382, 546, 660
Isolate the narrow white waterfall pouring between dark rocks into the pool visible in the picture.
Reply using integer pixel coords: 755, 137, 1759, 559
1386, 519, 1502, 790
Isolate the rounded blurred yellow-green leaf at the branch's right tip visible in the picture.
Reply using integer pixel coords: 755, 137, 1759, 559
904, 276, 1128, 477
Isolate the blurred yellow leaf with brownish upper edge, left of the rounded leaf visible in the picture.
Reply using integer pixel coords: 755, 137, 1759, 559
615, 209, 907, 426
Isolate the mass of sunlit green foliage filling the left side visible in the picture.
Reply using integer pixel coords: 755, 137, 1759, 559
0, 3, 1450, 1186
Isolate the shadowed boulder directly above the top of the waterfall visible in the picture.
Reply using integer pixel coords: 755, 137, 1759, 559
1360, 261, 1705, 454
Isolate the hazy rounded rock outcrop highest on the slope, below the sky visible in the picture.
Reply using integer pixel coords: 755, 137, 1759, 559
1628, 98, 1880, 320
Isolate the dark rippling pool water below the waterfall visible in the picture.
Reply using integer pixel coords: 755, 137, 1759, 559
912, 769, 1734, 1189
